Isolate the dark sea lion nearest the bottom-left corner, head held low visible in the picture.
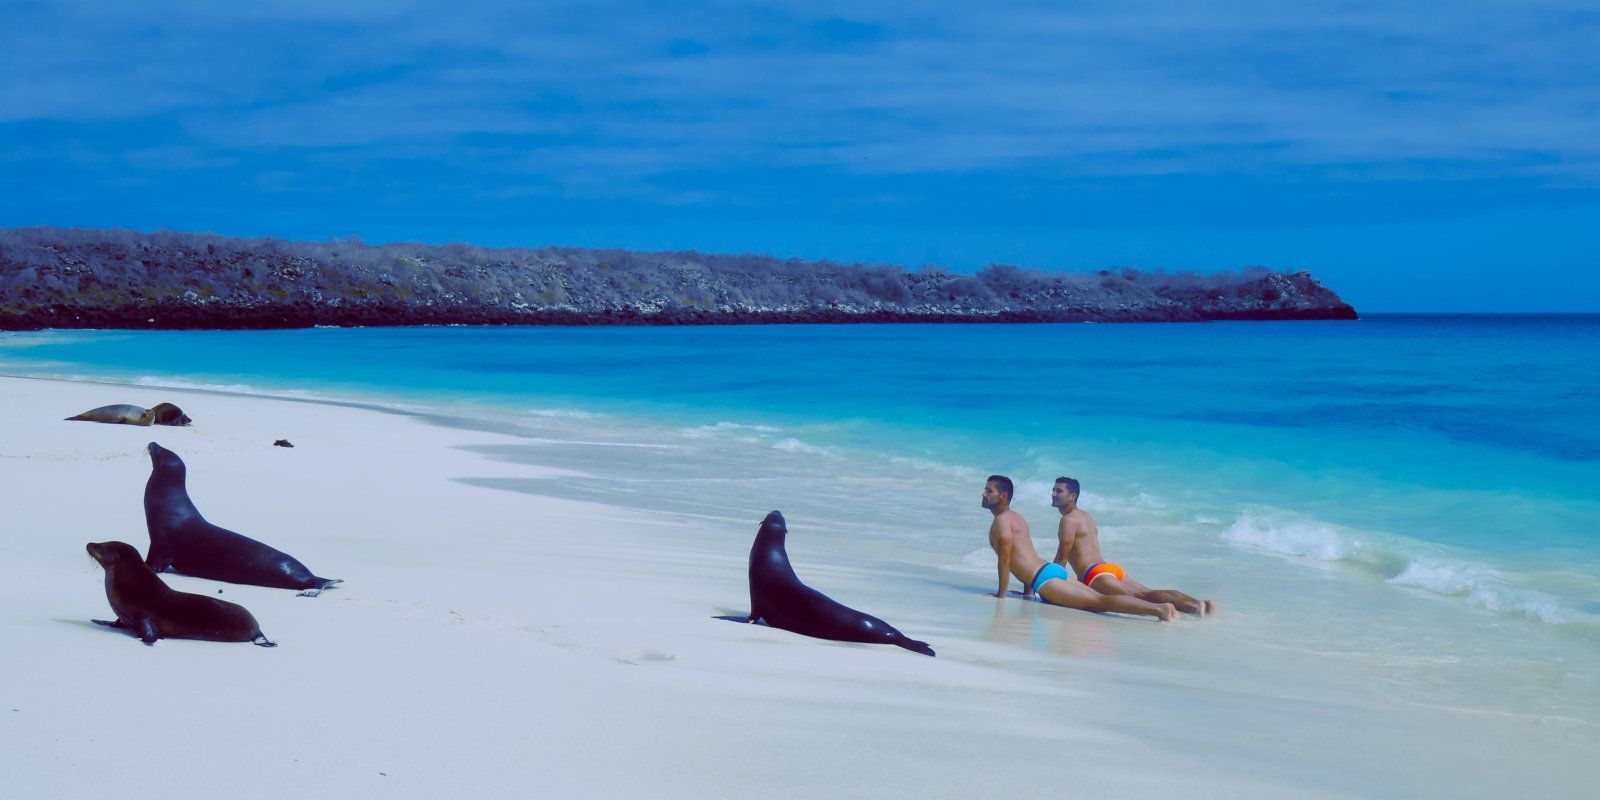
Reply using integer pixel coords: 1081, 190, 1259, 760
83, 542, 278, 648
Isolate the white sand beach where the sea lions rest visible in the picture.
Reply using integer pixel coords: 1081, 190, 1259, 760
0, 378, 1600, 800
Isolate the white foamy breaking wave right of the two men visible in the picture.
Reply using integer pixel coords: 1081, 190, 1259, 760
1222, 512, 1594, 626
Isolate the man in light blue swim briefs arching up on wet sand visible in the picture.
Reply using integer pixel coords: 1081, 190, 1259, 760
982, 475, 1178, 621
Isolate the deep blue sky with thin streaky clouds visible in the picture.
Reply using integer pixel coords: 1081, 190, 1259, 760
0, 0, 1600, 312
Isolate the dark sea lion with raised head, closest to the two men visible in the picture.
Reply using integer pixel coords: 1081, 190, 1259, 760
746, 510, 933, 656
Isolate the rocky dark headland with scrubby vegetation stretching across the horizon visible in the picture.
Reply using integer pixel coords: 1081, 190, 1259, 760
0, 227, 1355, 330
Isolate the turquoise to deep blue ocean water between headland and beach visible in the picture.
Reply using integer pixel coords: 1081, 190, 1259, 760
0, 315, 1600, 709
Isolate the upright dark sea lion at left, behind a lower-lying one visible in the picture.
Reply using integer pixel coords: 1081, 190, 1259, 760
144, 442, 342, 597
